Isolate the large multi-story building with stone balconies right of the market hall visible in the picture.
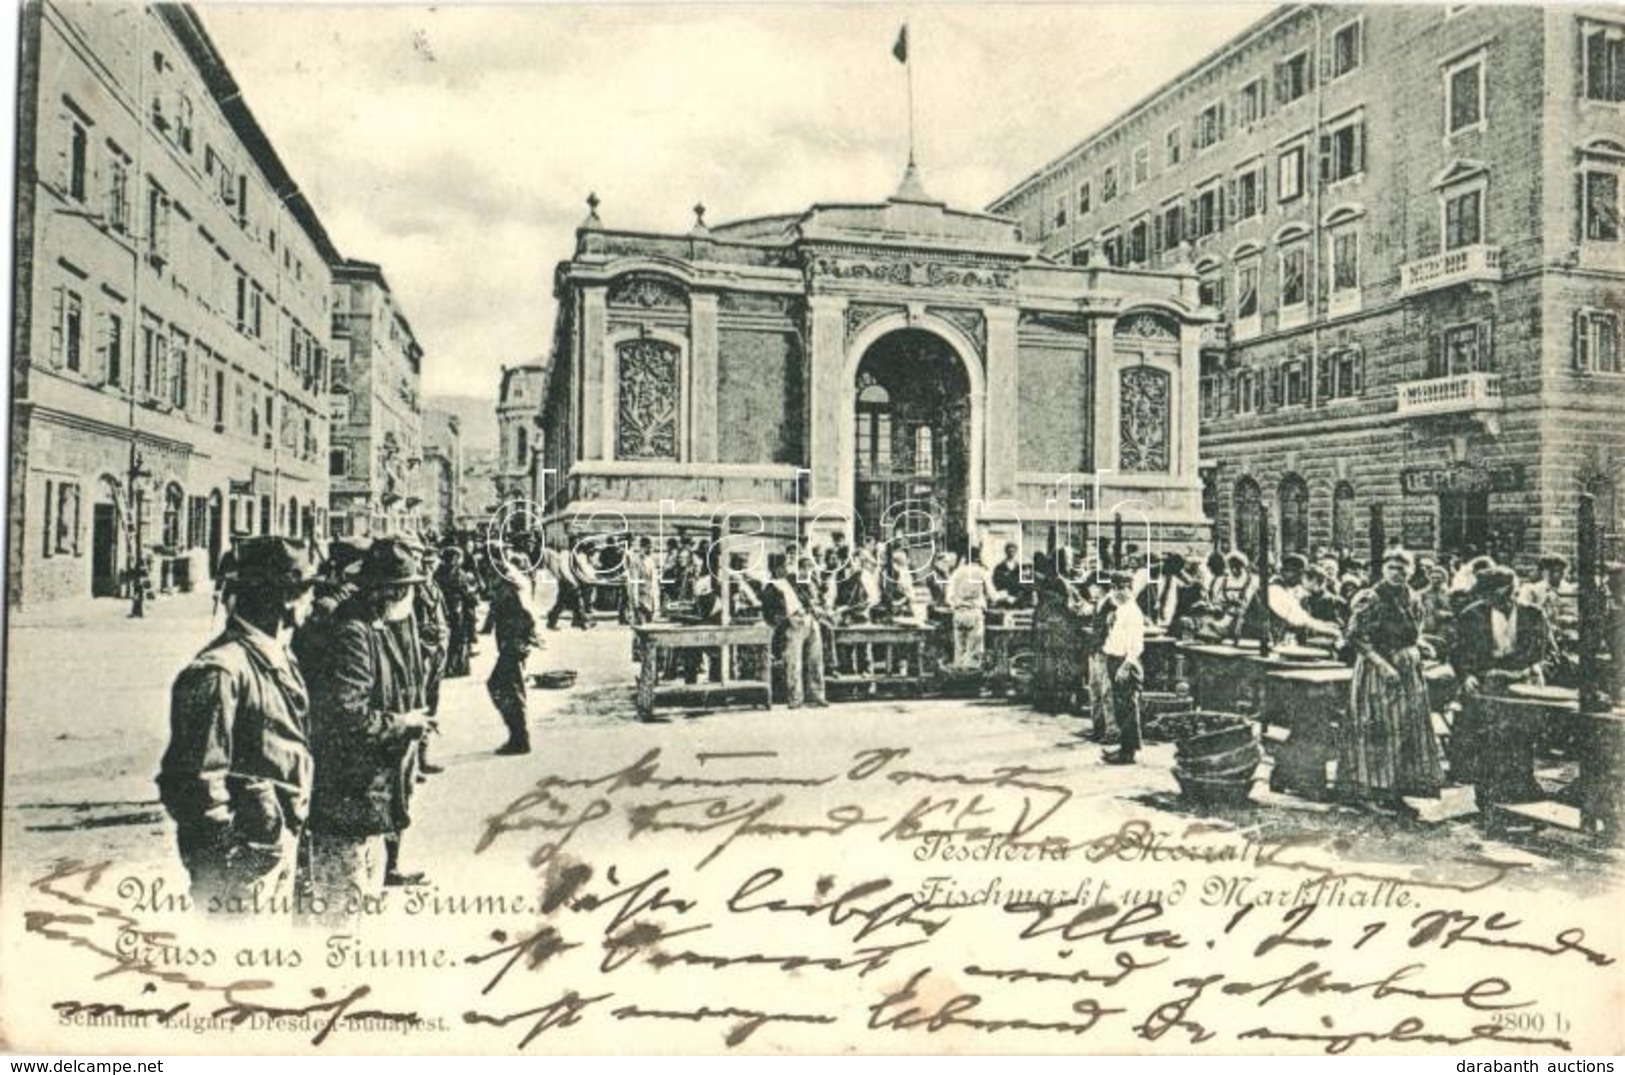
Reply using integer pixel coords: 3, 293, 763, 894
993, 5, 1625, 559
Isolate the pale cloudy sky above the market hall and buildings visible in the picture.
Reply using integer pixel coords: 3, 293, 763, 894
198, 2, 1271, 398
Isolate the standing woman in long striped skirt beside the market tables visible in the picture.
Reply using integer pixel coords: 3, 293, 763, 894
1337, 549, 1443, 815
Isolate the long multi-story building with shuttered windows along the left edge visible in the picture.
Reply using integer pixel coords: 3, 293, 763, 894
7, 0, 336, 604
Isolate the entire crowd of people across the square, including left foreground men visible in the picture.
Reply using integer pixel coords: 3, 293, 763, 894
158, 526, 1625, 913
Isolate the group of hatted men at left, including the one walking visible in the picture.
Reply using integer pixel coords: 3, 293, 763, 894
158, 536, 538, 921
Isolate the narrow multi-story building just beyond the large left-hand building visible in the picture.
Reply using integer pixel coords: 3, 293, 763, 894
328, 260, 429, 538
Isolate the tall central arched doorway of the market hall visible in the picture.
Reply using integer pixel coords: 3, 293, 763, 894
853, 328, 970, 567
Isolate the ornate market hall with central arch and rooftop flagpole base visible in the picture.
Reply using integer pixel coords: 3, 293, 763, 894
541, 174, 1211, 560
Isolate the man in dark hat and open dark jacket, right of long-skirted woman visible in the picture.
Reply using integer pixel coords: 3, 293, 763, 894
1451, 565, 1552, 812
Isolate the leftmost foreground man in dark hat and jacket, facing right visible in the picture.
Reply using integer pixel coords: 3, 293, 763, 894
158, 538, 317, 913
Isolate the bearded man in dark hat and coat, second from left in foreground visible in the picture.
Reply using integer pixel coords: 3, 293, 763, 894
310, 538, 429, 911
